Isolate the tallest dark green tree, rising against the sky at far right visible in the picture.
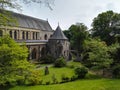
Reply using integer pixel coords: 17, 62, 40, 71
91, 11, 120, 45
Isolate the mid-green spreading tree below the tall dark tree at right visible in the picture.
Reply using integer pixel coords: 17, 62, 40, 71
82, 39, 113, 69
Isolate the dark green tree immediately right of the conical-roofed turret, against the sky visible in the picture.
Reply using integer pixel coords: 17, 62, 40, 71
68, 23, 89, 53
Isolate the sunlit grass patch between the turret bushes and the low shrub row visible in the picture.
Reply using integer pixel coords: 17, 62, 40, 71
40, 67, 74, 84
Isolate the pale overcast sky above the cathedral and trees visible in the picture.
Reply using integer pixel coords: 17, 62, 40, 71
17, 0, 120, 30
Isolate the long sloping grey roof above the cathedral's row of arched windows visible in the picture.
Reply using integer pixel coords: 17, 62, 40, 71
0, 9, 52, 31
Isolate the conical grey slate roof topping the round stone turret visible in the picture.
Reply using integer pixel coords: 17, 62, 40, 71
50, 26, 67, 40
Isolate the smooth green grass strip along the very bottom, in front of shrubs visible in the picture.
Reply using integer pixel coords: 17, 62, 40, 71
9, 79, 120, 90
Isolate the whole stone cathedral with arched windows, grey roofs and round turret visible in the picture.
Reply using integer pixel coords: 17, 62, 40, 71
0, 12, 70, 61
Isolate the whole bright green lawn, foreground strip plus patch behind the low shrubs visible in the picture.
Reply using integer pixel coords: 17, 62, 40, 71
5, 62, 120, 90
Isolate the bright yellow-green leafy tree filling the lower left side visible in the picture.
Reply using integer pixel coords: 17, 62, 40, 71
0, 36, 33, 85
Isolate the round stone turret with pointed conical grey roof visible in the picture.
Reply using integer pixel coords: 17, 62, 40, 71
48, 26, 70, 60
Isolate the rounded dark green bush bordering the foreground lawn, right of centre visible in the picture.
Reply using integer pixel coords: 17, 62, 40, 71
75, 67, 88, 79
